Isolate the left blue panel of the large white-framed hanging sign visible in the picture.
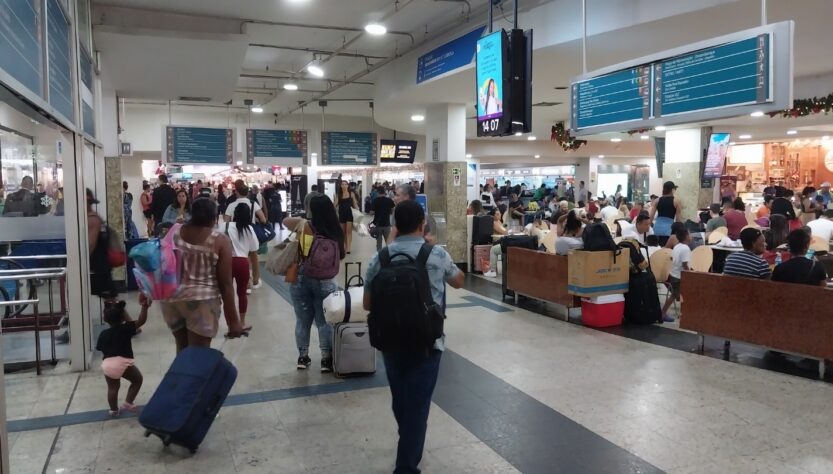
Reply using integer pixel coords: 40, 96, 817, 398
572, 66, 651, 128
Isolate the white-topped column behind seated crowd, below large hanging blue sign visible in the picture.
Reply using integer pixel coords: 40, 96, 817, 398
662, 127, 713, 222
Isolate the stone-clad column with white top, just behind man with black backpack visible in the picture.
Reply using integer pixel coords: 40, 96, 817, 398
425, 104, 468, 263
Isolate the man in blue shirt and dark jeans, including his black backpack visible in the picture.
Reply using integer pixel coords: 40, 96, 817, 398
364, 200, 465, 473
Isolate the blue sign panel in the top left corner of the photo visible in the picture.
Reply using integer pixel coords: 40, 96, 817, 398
0, 0, 43, 97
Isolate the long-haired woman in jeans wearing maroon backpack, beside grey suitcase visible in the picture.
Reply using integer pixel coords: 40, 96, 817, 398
283, 194, 345, 372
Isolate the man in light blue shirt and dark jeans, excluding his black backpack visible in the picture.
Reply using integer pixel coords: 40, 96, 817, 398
363, 200, 465, 473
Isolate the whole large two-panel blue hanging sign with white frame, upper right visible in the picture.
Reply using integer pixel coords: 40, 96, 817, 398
570, 22, 793, 135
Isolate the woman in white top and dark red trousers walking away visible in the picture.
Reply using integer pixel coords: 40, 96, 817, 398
226, 204, 260, 332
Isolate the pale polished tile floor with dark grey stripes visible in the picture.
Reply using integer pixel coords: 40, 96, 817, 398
6, 235, 833, 474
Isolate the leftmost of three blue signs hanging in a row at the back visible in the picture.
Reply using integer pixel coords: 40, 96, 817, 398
165, 127, 234, 164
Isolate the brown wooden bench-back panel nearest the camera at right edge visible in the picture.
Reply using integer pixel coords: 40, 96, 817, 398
680, 272, 833, 379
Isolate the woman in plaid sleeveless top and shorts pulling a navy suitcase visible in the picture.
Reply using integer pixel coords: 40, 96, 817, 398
160, 198, 243, 352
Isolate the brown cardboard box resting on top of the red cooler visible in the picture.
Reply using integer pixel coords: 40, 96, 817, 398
567, 250, 630, 297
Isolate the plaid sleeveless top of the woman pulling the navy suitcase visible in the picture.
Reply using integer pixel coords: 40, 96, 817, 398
168, 228, 220, 301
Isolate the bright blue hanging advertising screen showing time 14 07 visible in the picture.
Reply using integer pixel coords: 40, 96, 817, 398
476, 30, 508, 136
